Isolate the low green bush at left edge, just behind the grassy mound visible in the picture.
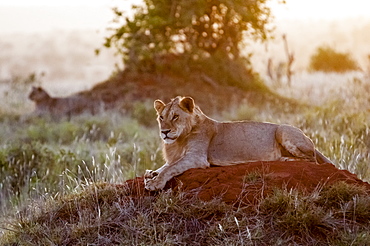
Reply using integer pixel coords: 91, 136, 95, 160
0, 142, 81, 200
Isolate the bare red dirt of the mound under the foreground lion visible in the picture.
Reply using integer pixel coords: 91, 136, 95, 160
124, 162, 370, 205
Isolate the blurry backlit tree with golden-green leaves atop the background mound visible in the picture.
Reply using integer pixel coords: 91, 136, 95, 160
105, 0, 278, 90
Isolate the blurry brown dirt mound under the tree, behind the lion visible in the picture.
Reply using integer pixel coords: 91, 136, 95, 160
80, 70, 274, 113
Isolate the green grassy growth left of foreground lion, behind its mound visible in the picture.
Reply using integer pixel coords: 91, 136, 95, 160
0, 114, 163, 215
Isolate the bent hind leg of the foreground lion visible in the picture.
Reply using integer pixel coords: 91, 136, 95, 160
276, 125, 316, 162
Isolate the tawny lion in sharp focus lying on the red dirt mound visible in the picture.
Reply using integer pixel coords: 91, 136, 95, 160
144, 96, 332, 190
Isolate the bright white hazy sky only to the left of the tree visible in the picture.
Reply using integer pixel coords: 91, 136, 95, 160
0, 0, 135, 34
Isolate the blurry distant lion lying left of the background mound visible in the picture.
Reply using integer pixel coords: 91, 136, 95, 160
28, 86, 94, 117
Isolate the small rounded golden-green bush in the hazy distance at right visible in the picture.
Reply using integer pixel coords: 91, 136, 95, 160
309, 46, 359, 73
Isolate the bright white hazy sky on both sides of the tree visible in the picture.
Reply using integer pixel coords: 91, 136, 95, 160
0, 0, 370, 34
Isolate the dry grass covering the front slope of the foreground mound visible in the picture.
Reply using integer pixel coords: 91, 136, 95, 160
1, 183, 370, 245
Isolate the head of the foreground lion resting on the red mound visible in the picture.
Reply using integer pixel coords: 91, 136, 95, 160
154, 96, 200, 144
